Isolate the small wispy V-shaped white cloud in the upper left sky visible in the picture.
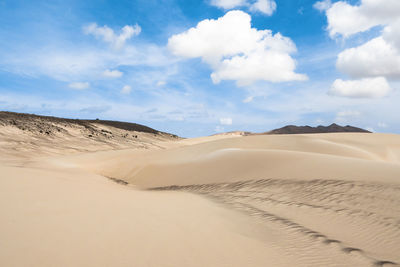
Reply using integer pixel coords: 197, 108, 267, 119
83, 23, 142, 49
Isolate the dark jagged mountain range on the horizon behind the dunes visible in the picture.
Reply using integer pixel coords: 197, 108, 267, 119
263, 123, 371, 134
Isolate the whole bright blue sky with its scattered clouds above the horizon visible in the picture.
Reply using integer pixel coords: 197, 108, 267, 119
0, 0, 400, 137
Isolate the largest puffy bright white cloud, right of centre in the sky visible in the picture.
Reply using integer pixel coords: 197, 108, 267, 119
168, 10, 307, 86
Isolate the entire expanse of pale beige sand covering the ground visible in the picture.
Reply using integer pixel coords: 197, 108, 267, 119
0, 133, 400, 267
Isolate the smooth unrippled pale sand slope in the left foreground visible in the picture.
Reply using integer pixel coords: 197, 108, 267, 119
0, 164, 296, 266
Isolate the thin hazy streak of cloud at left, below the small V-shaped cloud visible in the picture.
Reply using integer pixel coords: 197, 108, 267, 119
0, 39, 177, 82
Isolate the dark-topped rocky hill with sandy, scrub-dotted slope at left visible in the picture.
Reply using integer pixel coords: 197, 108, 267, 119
0, 112, 180, 161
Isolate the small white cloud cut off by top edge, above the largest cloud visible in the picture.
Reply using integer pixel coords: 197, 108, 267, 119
210, 0, 276, 16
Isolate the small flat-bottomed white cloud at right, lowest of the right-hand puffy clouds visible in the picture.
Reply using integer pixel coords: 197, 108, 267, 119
329, 77, 391, 98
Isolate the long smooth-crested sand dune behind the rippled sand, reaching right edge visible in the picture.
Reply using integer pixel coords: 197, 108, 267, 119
75, 134, 400, 188
